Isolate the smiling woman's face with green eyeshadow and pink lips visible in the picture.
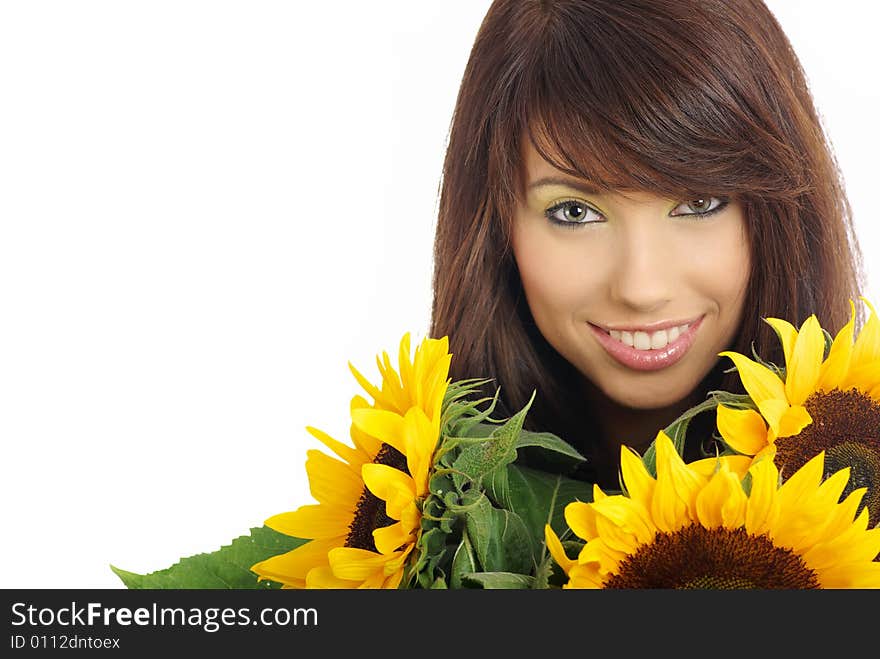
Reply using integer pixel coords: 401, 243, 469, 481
513, 144, 750, 409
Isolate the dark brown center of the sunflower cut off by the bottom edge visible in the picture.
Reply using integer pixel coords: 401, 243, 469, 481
605, 524, 820, 590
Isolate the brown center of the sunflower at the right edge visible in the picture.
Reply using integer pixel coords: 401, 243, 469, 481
774, 388, 880, 526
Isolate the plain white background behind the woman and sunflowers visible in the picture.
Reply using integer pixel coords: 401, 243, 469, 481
0, 0, 880, 588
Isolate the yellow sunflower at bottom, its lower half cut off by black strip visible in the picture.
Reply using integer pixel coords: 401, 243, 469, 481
545, 431, 880, 590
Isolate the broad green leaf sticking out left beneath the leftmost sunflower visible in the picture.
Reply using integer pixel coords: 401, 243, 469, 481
110, 526, 308, 590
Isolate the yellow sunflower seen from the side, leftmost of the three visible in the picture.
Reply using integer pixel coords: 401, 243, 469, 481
251, 334, 451, 588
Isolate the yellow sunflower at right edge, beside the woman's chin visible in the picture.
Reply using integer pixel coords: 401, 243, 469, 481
717, 298, 880, 526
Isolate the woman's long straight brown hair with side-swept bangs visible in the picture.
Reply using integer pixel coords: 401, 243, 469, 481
430, 0, 862, 448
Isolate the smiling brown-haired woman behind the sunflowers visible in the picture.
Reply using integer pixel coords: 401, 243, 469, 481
431, 0, 862, 488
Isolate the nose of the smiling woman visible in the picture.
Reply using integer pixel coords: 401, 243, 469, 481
610, 222, 687, 313
